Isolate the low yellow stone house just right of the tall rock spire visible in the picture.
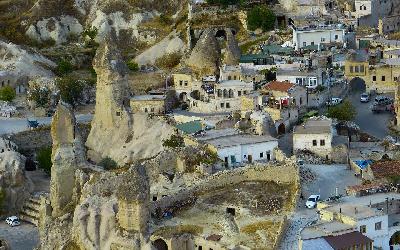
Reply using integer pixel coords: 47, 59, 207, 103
130, 95, 167, 115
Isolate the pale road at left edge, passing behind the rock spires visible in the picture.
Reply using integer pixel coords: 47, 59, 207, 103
0, 114, 93, 135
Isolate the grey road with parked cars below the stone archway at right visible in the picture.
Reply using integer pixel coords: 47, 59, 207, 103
349, 91, 393, 139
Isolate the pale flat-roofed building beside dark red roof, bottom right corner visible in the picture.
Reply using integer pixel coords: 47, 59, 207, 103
299, 193, 400, 250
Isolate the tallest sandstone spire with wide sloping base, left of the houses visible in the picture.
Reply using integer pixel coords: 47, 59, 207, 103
86, 38, 173, 164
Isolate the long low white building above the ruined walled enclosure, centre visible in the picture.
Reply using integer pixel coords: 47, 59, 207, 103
197, 129, 278, 166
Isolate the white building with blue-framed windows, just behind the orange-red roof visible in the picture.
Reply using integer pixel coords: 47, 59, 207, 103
276, 69, 325, 89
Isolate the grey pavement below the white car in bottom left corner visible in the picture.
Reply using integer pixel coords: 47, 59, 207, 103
0, 221, 39, 250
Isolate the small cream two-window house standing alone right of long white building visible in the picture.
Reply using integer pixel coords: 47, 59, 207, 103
293, 117, 333, 159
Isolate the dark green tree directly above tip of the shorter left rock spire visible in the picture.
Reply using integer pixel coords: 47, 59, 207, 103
56, 76, 85, 107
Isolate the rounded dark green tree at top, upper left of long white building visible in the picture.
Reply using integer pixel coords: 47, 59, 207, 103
247, 6, 276, 32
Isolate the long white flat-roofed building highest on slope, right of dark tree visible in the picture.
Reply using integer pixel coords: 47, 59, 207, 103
292, 24, 346, 50
